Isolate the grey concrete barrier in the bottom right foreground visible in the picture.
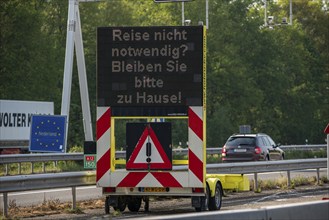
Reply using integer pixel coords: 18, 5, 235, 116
140, 200, 329, 220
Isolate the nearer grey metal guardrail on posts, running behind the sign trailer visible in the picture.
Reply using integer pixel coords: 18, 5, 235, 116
0, 158, 327, 216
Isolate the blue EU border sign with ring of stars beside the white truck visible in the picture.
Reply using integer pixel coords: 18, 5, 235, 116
30, 115, 66, 153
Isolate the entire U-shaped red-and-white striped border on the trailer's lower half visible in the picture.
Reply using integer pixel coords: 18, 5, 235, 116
96, 107, 204, 188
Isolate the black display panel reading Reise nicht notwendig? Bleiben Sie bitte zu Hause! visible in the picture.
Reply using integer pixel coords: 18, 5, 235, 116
97, 26, 204, 116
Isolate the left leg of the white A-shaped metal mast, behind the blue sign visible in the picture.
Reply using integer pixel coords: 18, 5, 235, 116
61, 0, 78, 152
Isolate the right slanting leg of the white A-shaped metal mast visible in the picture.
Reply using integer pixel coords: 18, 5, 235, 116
74, 1, 93, 141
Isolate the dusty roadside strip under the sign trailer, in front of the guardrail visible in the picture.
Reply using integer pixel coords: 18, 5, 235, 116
17, 184, 329, 220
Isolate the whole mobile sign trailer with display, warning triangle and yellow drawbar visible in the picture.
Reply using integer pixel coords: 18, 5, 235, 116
93, 26, 249, 213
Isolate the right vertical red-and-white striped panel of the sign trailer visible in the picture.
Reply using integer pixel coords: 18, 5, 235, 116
188, 106, 205, 187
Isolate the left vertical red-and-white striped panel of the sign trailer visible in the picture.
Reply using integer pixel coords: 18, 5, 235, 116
96, 107, 111, 187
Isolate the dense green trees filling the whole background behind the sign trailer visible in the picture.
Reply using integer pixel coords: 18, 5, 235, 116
0, 0, 329, 150
